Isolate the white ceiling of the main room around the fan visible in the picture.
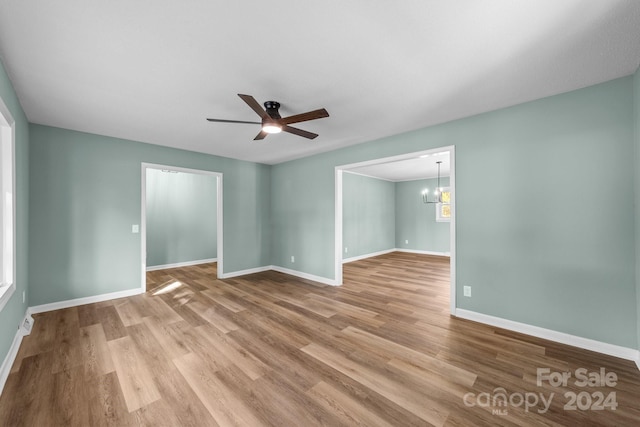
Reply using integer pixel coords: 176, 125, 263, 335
0, 0, 640, 164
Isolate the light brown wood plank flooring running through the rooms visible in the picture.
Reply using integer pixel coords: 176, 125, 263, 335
0, 253, 640, 427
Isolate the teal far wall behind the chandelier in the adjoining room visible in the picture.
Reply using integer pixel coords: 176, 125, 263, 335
395, 178, 451, 252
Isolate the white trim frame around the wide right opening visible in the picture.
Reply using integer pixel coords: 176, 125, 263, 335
334, 146, 456, 314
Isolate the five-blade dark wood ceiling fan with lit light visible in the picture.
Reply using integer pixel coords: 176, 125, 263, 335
207, 94, 329, 141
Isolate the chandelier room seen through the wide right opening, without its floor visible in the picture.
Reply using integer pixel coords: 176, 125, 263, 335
335, 147, 456, 314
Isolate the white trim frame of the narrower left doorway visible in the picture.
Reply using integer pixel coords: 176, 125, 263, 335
140, 163, 224, 292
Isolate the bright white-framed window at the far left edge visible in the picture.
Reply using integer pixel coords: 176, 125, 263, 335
0, 95, 16, 310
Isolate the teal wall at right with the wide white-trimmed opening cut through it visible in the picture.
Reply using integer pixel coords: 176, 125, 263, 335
271, 77, 638, 348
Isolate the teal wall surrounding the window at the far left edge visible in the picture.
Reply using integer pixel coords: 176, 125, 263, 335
0, 58, 30, 370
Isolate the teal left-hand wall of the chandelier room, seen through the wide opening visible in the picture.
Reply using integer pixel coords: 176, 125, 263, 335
342, 172, 396, 258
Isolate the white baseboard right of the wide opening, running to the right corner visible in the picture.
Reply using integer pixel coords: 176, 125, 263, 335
455, 308, 640, 369
